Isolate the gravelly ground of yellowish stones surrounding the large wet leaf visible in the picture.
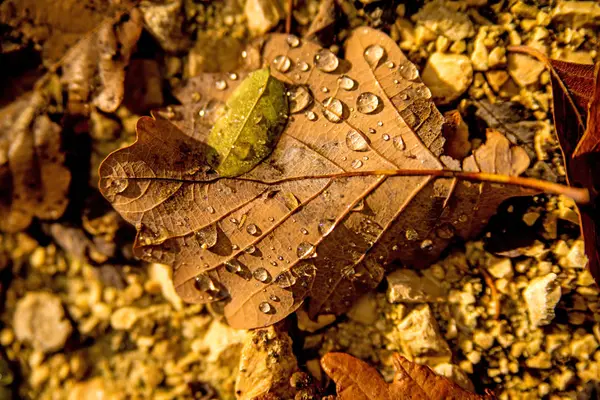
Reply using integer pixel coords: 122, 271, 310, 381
0, 0, 600, 399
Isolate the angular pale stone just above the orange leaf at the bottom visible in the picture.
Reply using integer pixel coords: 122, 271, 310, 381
398, 304, 452, 360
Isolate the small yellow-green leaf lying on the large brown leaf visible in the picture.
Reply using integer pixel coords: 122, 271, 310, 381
208, 68, 288, 177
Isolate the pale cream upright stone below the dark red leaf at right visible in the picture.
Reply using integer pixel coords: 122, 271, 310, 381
523, 273, 561, 327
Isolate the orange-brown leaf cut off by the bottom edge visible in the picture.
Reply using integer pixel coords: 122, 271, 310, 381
321, 353, 496, 400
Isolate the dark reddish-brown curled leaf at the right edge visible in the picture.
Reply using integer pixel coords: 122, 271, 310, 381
513, 47, 600, 283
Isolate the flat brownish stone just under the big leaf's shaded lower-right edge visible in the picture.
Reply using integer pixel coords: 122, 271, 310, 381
387, 269, 446, 303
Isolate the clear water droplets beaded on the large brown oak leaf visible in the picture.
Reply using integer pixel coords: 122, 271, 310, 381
196, 35, 436, 314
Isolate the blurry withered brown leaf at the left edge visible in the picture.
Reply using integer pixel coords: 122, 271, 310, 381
0, 92, 71, 232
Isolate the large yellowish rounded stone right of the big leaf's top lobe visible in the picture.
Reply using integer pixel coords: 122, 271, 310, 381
422, 53, 473, 104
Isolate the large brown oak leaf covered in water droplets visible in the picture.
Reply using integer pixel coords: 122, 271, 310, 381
100, 28, 540, 328
